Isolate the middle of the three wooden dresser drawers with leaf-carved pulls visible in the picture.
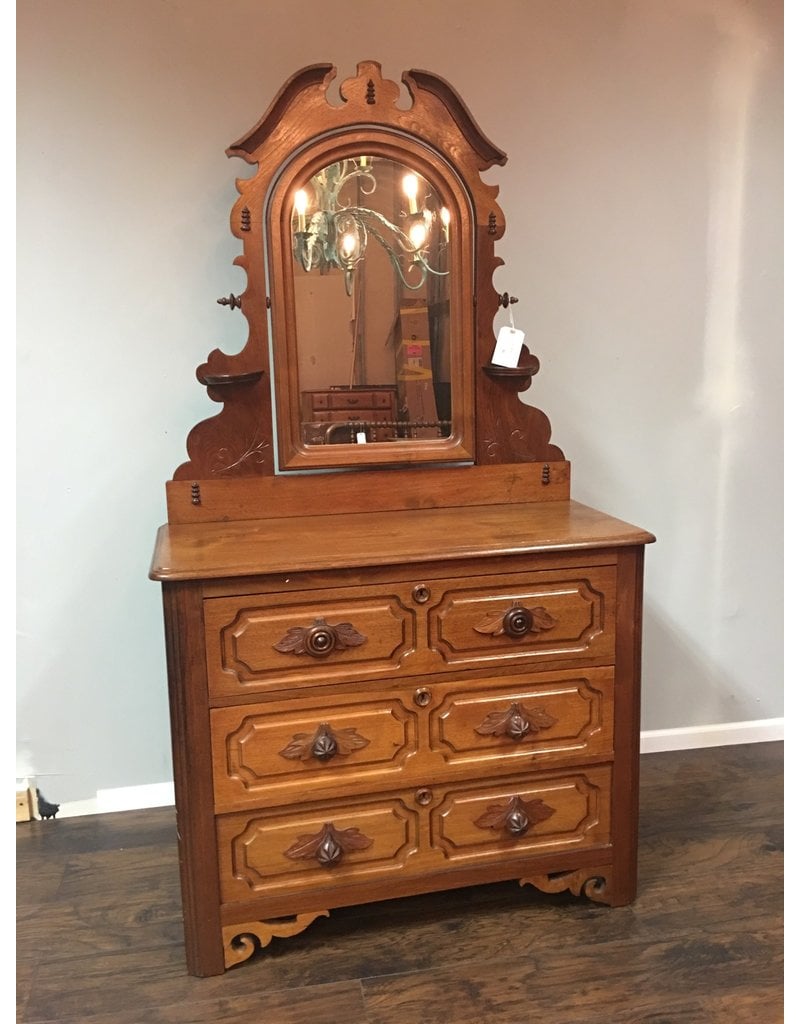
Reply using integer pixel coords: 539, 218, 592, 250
210, 668, 614, 813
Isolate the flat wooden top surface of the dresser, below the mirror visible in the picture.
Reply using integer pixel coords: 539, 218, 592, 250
150, 501, 655, 582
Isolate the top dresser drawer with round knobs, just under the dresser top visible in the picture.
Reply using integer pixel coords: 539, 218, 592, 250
204, 565, 617, 698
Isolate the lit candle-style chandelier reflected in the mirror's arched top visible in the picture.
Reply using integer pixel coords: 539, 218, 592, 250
292, 157, 450, 295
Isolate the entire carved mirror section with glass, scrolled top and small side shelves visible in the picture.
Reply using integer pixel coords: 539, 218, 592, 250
175, 61, 563, 480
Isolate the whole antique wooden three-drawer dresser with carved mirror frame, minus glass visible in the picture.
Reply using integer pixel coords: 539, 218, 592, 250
151, 62, 654, 976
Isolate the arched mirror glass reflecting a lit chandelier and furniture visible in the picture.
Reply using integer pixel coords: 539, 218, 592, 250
292, 156, 453, 444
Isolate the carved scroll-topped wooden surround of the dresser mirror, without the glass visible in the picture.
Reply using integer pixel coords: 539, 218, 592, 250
173, 60, 563, 483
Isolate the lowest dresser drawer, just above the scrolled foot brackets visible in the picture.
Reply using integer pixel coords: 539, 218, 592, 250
217, 765, 612, 903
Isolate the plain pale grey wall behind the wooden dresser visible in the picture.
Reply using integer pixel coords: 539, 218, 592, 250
16, 0, 783, 801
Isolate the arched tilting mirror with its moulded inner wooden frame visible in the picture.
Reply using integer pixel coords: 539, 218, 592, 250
266, 130, 474, 468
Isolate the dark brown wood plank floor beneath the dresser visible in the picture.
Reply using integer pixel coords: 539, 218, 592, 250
16, 743, 784, 1024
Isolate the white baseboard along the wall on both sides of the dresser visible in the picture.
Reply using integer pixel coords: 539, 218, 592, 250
40, 718, 784, 818
